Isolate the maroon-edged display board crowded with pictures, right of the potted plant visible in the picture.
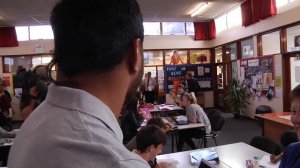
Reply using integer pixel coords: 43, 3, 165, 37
240, 56, 275, 100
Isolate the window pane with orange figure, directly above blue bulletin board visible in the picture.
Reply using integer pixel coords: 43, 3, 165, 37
165, 50, 187, 65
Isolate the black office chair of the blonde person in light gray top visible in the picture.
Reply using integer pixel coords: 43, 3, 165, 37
198, 113, 225, 148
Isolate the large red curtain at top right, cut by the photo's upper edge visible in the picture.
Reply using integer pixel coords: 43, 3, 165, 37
241, 0, 277, 26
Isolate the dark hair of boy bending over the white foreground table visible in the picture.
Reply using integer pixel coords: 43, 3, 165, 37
136, 125, 167, 153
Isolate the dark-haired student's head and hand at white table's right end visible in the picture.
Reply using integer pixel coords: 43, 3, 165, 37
270, 131, 298, 163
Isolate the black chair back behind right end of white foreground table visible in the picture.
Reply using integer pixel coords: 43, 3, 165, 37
250, 136, 281, 155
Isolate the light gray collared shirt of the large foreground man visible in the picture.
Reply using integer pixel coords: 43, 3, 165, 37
8, 85, 149, 168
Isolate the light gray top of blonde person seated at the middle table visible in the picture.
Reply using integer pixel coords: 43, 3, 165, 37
186, 104, 211, 134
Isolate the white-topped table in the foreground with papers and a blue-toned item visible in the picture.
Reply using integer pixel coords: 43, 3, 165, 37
156, 142, 270, 168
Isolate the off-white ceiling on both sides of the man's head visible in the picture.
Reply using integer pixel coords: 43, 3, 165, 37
0, 0, 244, 26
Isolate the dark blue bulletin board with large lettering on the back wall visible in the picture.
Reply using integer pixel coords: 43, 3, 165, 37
164, 64, 212, 93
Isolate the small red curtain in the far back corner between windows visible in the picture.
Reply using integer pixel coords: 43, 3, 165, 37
194, 20, 216, 40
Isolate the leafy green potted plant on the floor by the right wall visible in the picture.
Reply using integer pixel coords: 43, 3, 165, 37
224, 78, 250, 118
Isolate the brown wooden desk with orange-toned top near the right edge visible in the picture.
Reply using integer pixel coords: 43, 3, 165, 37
255, 112, 294, 143
